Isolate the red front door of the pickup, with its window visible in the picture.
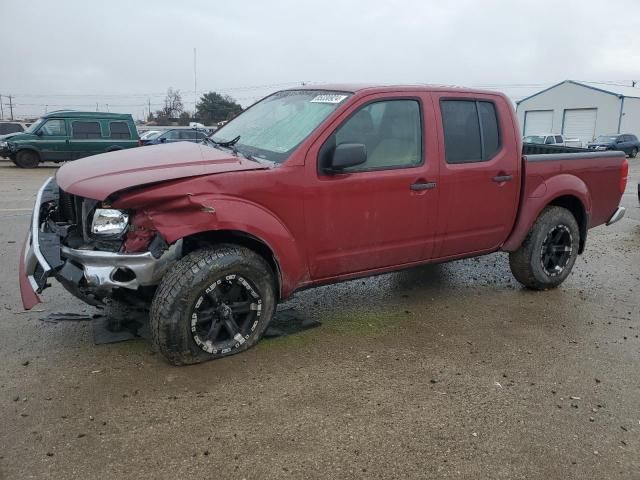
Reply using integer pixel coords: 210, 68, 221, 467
304, 96, 438, 280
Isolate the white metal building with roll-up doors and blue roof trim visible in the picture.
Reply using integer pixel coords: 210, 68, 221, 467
516, 80, 640, 142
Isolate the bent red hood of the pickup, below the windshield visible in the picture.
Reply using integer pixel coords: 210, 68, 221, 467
56, 142, 267, 200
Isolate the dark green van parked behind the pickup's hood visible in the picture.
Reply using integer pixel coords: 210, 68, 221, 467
0, 110, 139, 168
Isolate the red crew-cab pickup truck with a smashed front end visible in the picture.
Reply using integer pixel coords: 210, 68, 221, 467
20, 85, 628, 364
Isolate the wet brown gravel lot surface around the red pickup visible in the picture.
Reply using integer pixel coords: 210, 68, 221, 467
0, 160, 640, 479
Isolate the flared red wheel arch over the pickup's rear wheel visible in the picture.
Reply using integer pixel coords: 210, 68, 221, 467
502, 174, 591, 252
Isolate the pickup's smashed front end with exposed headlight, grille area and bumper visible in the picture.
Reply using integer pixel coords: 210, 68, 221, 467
20, 178, 182, 310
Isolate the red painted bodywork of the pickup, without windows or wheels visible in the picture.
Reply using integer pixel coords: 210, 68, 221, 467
53, 86, 624, 298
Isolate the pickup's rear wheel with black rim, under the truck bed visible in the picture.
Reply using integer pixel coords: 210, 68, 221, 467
509, 206, 580, 290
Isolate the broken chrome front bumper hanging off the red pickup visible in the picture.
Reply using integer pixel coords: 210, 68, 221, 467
19, 178, 182, 310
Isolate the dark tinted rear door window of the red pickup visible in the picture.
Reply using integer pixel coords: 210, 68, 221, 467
440, 98, 502, 164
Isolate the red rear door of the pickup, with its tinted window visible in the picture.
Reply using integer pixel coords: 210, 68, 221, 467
433, 93, 521, 258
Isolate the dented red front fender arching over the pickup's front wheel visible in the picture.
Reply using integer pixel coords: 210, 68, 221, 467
114, 195, 309, 298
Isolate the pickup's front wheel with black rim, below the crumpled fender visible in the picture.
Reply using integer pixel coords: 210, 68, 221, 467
150, 245, 277, 365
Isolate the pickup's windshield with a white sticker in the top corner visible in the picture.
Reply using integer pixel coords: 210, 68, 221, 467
211, 90, 351, 163
